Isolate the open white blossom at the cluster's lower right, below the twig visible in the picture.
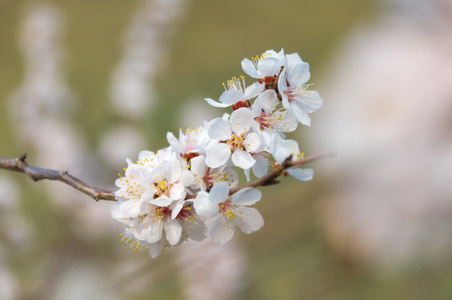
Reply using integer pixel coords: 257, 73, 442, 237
194, 182, 264, 245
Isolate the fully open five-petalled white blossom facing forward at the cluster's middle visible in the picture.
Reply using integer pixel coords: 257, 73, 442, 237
206, 107, 261, 169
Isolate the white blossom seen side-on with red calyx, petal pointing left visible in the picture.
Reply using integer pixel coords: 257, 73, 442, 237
204, 76, 265, 110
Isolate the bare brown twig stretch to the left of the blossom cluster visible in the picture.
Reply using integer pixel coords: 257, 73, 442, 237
0, 153, 116, 201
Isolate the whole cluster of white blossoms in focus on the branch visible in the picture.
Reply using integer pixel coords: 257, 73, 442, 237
111, 50, 322, 257
